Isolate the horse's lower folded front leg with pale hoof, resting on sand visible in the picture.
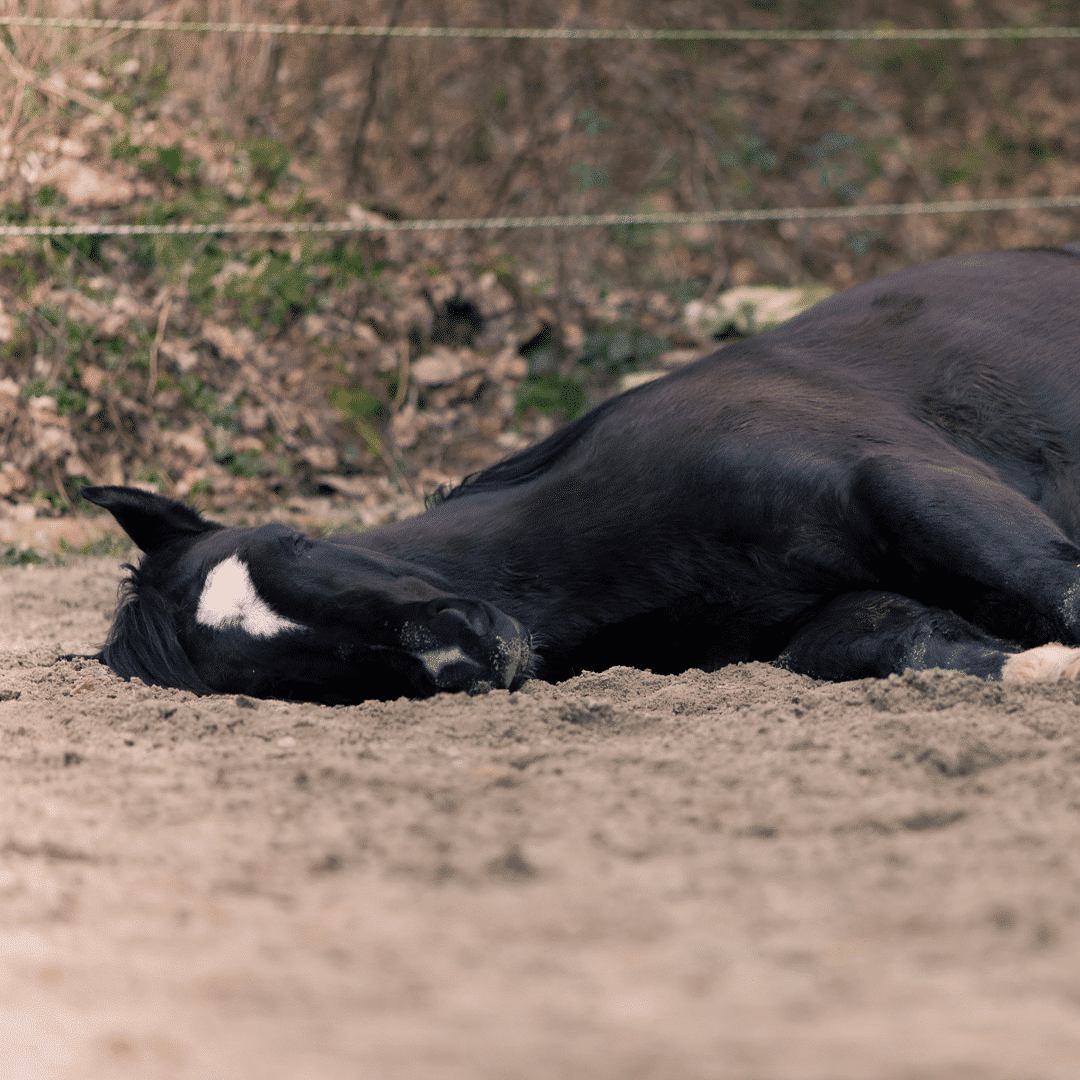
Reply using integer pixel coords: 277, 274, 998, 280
774, 591, 1080, 683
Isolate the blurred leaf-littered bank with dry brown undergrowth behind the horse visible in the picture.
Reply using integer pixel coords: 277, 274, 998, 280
0, 0, 1080, 540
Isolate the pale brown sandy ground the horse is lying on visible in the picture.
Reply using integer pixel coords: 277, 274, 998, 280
0, 558, 1080, 1080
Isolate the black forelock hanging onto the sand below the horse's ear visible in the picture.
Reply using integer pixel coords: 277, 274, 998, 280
100, 563, 214, 694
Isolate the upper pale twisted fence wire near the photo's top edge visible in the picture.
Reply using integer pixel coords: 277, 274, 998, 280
0, 15, 1080, 41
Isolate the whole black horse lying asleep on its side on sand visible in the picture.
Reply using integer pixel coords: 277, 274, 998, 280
83, 245, 1080, 702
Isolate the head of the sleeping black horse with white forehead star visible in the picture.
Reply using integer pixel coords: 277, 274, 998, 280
82, 487, 531, 702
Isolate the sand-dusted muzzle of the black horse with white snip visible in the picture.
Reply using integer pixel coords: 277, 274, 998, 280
403, 599, 532, 694
